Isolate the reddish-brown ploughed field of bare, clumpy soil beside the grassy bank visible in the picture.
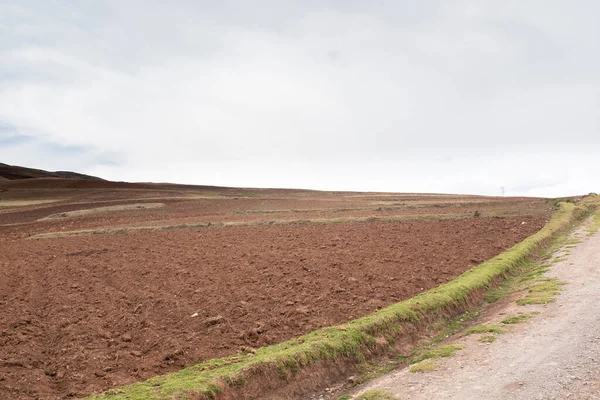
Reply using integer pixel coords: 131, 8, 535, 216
0, 183, 549, 399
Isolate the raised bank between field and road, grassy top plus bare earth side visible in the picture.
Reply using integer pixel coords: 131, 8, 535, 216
87, 196, 596, 400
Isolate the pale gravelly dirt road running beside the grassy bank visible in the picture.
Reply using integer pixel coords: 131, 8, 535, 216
355, 220, 600, 400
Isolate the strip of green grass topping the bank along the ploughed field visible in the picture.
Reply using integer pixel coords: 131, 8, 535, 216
88, 203, 590, 400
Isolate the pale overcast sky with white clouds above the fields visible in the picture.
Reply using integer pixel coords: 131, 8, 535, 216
0, 0, 600, 197
